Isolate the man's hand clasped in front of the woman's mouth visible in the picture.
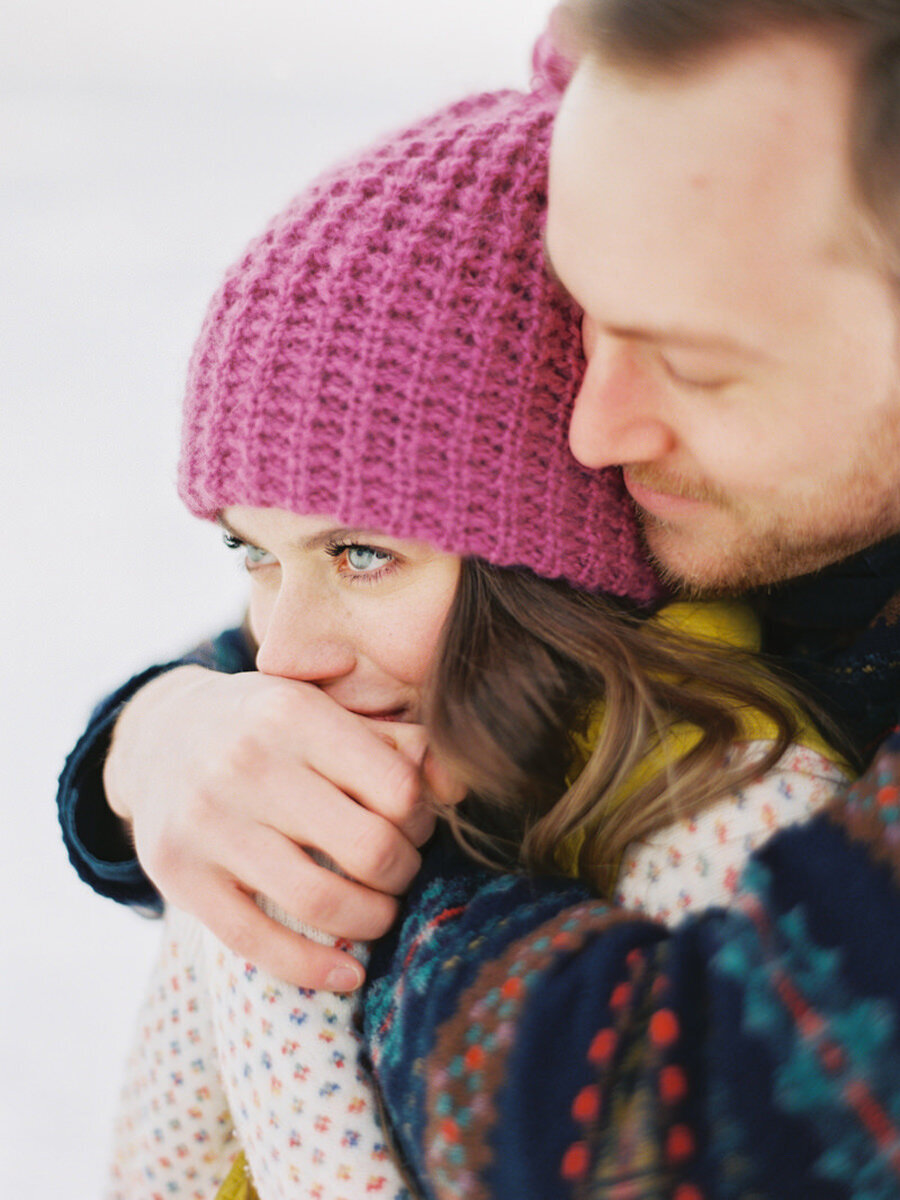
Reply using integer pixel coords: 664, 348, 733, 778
103, 666, 446, 991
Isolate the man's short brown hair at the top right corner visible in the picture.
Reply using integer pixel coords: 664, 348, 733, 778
564, 0, 900, 277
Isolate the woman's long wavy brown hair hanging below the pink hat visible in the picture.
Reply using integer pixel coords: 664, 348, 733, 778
424, 559, 830, 894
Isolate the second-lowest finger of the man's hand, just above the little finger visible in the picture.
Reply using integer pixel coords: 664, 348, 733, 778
222, 829, 397, 941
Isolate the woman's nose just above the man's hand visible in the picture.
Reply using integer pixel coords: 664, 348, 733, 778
257, 582, 356, 684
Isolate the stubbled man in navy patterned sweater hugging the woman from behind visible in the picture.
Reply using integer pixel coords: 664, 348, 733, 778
62, 0, 900, 1200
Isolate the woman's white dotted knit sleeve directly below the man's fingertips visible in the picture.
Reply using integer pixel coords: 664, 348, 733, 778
204, 901, 410, 1200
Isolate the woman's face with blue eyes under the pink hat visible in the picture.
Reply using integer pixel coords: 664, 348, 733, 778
220, 506, 460, 721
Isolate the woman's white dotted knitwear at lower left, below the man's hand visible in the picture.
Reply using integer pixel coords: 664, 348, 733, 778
107, 902, 410, 1200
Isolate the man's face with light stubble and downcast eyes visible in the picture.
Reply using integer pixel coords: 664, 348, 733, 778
547, 35, 900, 589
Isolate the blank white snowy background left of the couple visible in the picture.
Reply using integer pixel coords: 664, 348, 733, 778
0, 0, 551, 1200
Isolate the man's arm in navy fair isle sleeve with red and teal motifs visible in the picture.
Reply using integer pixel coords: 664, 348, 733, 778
366, 736, 900, 1200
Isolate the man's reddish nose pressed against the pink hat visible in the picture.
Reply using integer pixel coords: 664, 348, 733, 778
569, 330, 676, 467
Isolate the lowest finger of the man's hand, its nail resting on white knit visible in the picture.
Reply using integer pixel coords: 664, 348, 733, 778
188, 881, 365, 991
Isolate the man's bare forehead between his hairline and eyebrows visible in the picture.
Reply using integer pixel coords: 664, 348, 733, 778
547, 31, 864, 338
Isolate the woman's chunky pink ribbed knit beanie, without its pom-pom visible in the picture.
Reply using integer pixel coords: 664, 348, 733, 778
179, 81, 660, 602
